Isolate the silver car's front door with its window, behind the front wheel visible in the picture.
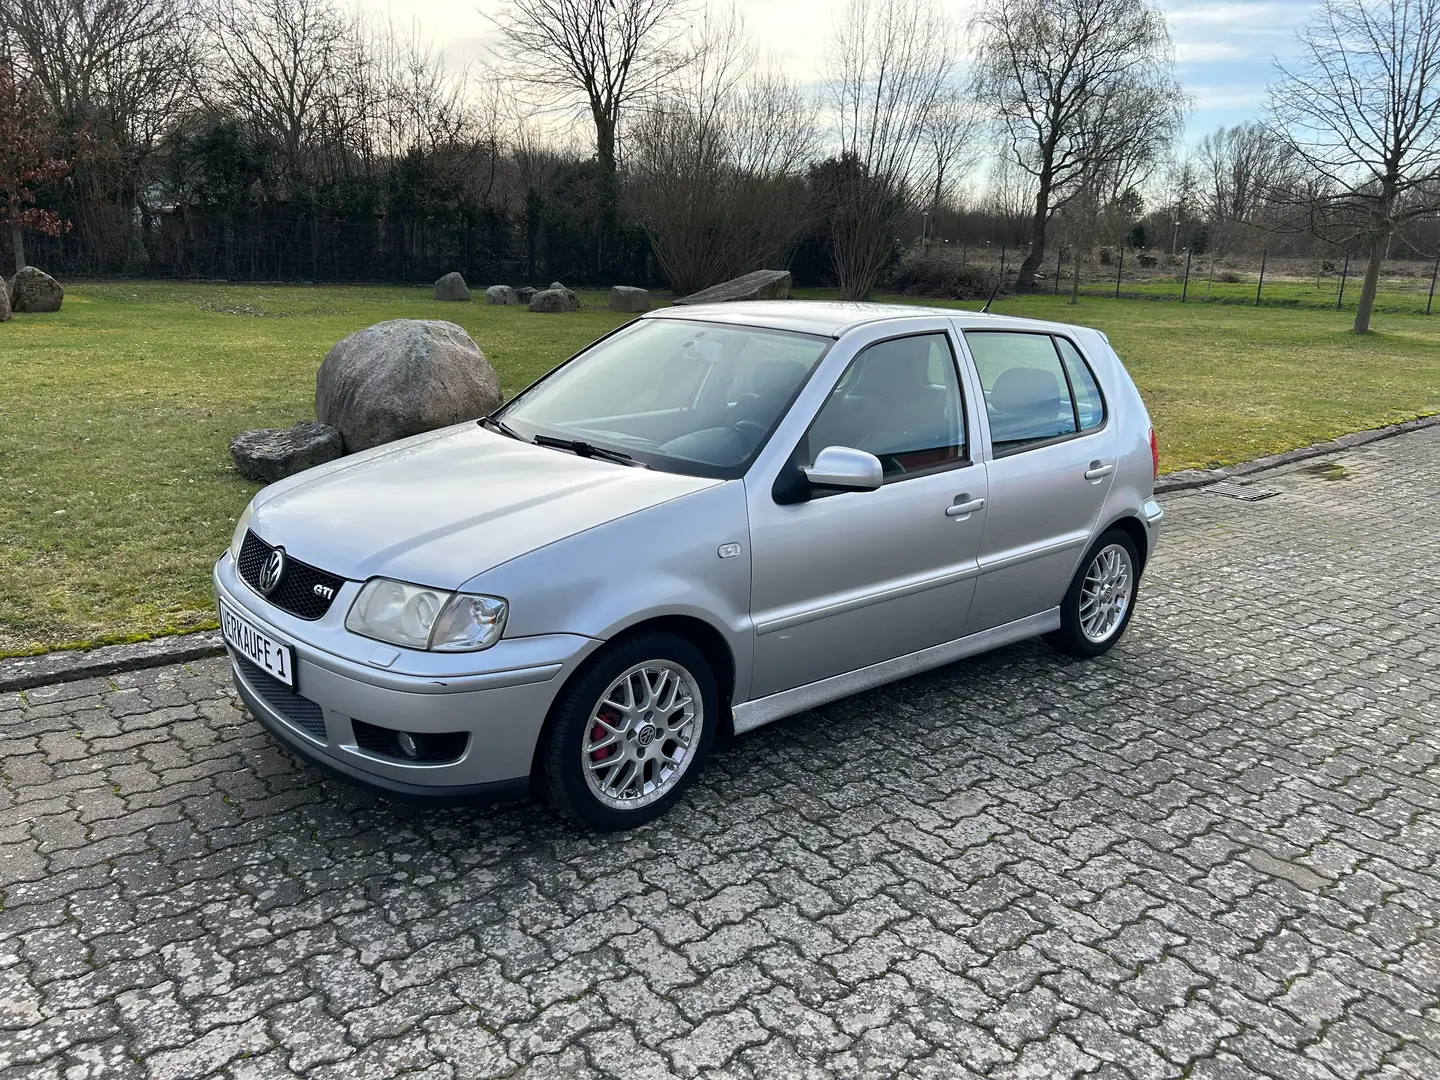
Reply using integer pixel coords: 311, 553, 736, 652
746, 330, 986, 697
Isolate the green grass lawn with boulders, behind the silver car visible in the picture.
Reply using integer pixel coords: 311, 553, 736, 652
8, 282, 1440, 657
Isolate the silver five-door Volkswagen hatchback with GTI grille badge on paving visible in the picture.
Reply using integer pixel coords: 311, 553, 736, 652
215, 301, 1162, 828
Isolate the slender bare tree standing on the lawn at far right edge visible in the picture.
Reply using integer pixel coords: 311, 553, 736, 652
1270, 0, 1440, 334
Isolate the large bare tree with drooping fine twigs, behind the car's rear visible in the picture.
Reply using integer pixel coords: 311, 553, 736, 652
976, 0, 1185, 291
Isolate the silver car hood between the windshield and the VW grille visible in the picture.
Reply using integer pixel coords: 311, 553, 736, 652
251, 423, 721, 589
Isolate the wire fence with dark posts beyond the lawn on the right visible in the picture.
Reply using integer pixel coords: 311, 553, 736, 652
933, 248, 1440, 315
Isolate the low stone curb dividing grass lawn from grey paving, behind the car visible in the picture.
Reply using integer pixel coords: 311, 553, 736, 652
11, 415, 1440, 693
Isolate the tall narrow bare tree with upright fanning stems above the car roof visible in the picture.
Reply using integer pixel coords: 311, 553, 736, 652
824, 0, 953, 300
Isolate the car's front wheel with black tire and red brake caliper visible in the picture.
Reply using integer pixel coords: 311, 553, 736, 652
540, 632, 719, 831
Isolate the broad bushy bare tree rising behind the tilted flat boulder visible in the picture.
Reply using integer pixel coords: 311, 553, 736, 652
626, 7, 815, 292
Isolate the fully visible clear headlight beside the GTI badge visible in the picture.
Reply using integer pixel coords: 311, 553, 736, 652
346, 577, 508, 652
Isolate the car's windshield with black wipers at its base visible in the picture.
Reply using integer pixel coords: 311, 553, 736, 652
497, 318, 831, 478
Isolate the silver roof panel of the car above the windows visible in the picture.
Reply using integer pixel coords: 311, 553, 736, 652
644, 300, 1088, 337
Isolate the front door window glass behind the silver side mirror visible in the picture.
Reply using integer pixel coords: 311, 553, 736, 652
801, 334, 966, 481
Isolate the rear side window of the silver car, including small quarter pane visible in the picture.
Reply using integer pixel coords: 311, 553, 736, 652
965, 330, 1104, 454
